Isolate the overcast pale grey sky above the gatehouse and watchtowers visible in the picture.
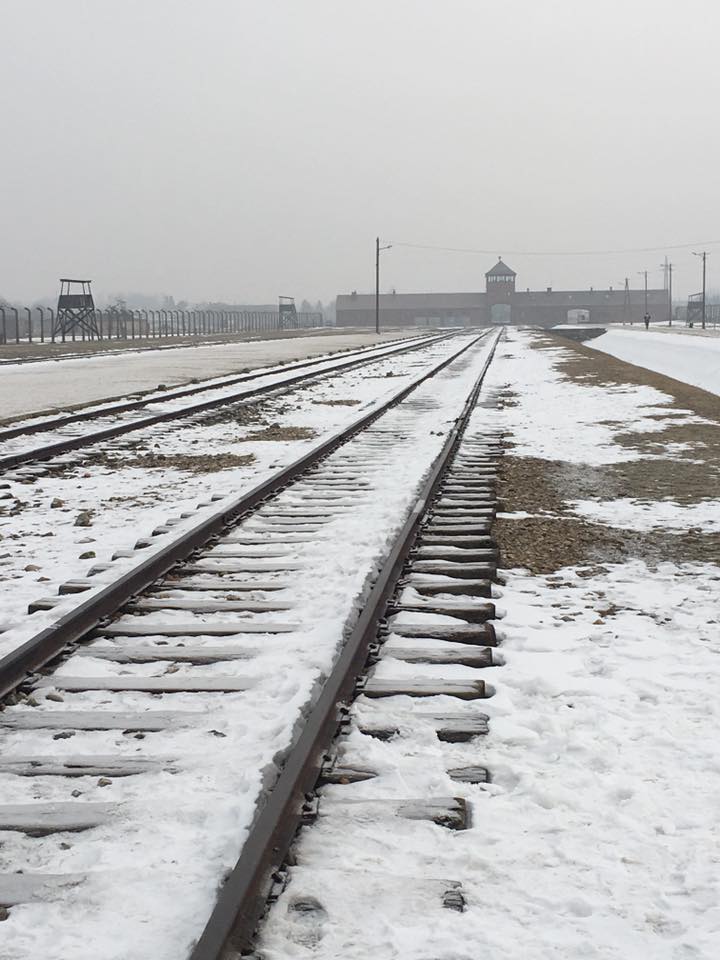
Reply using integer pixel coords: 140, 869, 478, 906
0, 0, 720, 302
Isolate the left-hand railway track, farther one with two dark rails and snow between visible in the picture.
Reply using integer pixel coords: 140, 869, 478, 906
0, 334, 453, 480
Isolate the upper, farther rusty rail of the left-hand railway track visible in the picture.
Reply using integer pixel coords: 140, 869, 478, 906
0, 334, 454, 446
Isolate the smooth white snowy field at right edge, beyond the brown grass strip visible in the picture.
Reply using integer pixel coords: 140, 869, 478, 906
586, 328, 720, 394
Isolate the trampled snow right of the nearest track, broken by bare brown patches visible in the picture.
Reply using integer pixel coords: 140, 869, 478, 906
466, 331, 720, 960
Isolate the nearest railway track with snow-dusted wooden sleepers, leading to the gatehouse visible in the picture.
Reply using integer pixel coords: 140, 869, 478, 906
0, 328, 498, 960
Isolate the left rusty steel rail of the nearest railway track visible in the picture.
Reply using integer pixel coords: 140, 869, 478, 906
0, 334, 484, 697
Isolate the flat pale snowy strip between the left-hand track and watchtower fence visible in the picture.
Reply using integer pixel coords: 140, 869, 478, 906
0, 330, 418, 419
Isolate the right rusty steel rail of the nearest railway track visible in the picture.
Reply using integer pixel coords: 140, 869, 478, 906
189, 331, 502, 960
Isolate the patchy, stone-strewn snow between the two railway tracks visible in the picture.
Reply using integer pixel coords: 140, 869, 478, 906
0, 338, 478, 655
